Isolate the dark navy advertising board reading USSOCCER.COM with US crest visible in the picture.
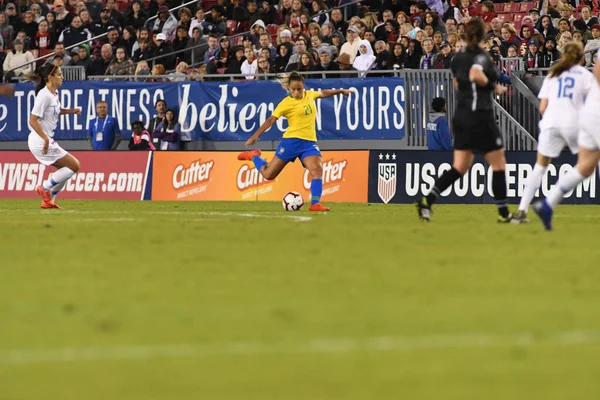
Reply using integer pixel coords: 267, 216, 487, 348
368, 150, 600, 204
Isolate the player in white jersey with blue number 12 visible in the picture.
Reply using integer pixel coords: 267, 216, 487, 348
511, 42, 594, 224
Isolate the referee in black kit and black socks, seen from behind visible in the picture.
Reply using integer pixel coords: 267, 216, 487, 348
415, 18, 512, 223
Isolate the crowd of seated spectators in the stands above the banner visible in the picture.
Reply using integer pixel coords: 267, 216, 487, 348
0, 0, 600, 82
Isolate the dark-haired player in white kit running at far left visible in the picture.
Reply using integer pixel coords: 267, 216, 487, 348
27, 64, 81, 208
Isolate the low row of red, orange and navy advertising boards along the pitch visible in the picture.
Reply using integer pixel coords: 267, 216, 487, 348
0, 149, 600, 204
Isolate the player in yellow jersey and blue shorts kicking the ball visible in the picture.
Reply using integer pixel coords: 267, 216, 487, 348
238, 72, 351, 211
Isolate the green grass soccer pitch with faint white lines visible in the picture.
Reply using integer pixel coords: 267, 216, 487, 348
0, 200, 600, 400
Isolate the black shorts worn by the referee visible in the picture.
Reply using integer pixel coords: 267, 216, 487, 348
452, 108, 504, 154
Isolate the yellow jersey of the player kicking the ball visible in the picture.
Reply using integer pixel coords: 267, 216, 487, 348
273, 90, 321, 142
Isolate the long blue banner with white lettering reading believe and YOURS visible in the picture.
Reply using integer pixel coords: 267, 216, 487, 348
0, 78, 406, 141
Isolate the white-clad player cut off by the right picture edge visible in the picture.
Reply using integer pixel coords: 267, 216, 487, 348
533, 50, 600, 230
